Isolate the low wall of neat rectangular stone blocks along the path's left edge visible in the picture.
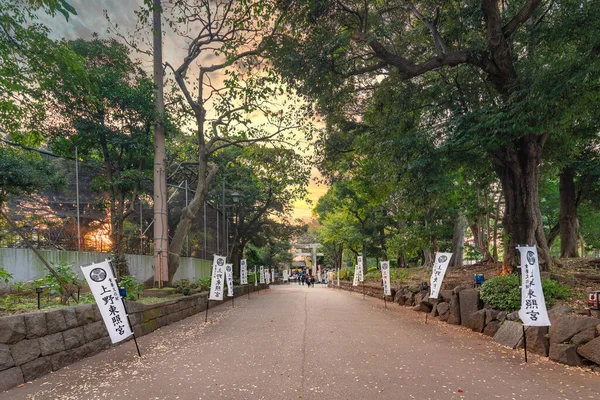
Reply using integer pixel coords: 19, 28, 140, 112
0, 285, 268, 391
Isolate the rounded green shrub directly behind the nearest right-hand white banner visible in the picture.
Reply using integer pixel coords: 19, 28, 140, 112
480, 274, 572, 312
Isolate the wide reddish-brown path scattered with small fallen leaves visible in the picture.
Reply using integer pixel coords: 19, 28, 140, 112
0, 284, 600, 400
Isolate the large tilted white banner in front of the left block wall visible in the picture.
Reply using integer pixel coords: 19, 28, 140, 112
81, 261, 133, 343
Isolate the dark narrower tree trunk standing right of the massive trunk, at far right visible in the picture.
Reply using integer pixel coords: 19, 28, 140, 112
559, 167, 579, 258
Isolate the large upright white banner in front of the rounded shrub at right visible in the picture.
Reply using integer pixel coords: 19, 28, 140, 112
517, 246, 550, 326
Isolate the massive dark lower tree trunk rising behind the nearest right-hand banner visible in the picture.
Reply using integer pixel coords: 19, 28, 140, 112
493, 134, 552, 272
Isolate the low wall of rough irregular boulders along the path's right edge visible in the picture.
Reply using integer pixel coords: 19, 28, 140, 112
329, 281, 600, 370
